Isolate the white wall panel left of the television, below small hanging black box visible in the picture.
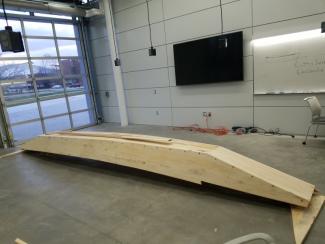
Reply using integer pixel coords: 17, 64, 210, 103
123, 68, 169, 89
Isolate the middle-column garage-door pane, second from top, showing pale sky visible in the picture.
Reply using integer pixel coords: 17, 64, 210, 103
27, 38, 57, 57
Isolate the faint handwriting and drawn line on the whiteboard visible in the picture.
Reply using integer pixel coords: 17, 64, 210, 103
265, 53, 325, 75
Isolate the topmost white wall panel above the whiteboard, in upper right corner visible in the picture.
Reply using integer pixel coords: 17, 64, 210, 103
253, 0, 325, 25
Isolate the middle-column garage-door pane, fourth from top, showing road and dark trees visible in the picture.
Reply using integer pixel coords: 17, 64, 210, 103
36, 79, 64, 98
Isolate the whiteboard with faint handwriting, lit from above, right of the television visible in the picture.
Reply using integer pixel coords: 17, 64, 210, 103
254, 34, 325, 94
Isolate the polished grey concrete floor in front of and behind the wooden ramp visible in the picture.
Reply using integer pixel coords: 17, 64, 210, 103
0, 124, 325, 244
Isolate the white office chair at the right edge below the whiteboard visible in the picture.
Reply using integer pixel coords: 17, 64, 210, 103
302, 96, 325, 145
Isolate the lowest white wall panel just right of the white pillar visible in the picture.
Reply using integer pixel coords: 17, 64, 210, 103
128, 108, 172, 125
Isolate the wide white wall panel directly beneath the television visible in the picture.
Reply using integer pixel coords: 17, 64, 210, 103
171, 81, 253, 107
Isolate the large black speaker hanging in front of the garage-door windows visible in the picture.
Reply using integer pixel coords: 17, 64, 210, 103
0, 26, 25, 53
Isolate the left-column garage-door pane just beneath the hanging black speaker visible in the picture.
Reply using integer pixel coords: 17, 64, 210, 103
0, 60, 30, 80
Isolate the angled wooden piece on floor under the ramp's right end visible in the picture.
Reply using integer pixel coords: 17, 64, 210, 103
291, 195, 325, 244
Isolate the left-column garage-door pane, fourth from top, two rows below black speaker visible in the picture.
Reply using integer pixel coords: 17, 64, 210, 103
1, 81, 35, 101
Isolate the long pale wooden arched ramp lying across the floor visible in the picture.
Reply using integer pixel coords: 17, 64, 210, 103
22, 132, 315, 207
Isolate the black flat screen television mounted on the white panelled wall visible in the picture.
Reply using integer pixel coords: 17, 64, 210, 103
174, 32, 244, 86
